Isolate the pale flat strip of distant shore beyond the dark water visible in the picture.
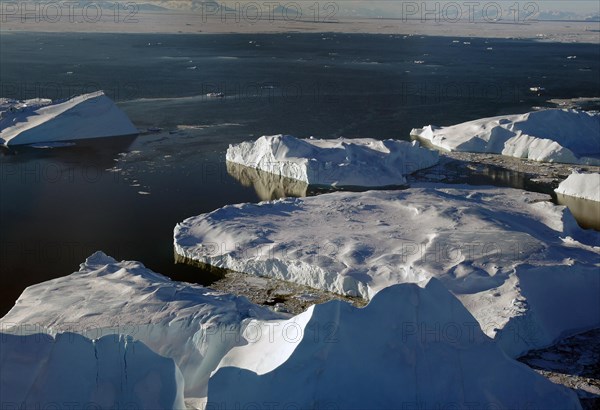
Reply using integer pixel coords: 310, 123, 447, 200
0, 9, 600, 44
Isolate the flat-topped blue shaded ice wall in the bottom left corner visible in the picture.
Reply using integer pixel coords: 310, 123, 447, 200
0, 333, 185, 410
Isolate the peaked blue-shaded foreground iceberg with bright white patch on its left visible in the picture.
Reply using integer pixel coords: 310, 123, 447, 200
207, 279, 580, 410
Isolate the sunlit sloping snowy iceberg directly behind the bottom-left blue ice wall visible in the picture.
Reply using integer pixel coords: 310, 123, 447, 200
0, 252, 286, 398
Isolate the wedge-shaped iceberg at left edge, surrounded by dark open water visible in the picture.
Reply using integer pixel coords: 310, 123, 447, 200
0, 91, 138, 145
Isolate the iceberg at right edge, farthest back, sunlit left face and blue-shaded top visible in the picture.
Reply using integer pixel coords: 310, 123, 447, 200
411, 109, 600, 165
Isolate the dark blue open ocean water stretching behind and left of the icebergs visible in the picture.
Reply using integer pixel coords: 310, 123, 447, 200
0, 33, 600, 314
